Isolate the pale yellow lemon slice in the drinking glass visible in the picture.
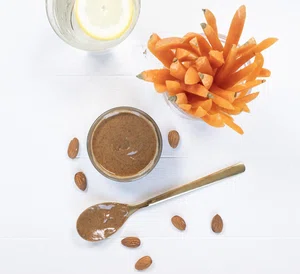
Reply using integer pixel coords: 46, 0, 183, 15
75, 0, 133, 40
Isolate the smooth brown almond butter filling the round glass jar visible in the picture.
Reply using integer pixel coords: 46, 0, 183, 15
91, 112, 158, 177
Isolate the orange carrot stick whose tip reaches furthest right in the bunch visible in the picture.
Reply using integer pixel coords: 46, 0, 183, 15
232, 38, 278, 71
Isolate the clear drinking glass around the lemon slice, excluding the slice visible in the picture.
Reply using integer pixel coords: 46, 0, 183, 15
46, 0, 141, 52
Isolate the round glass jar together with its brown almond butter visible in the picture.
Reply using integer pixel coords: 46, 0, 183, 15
87, 107, 162, 182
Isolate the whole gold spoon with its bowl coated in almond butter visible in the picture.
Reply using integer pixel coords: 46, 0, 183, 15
77, 163, 245, 242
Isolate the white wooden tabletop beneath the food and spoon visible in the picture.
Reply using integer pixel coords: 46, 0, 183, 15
0, 0, 300, 274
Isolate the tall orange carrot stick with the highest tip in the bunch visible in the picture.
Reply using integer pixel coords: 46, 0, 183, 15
224, 5, 246, 59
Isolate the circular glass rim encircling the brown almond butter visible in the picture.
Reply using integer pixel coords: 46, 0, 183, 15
86, 106, 163, 183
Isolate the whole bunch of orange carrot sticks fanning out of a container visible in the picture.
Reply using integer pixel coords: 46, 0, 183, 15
137, 5, 278, 134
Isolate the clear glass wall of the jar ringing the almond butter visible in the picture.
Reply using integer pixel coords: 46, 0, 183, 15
87, 107, 162, 182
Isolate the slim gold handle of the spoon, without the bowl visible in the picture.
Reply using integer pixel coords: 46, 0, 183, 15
138, 163, 246, 208
